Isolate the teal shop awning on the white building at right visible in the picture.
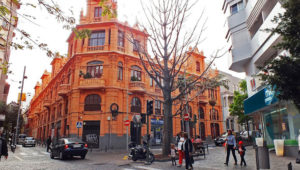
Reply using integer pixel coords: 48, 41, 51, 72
244, 87, 278, 115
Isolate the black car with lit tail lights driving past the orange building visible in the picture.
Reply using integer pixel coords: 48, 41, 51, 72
50, 138, 88, 160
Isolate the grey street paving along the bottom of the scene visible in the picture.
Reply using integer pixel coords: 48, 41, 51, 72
0, 146, 300, 170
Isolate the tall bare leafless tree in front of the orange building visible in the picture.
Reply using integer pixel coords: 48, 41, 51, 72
129, 0, 226, 155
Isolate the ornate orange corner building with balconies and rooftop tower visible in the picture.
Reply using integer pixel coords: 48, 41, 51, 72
28, 0, 223, 149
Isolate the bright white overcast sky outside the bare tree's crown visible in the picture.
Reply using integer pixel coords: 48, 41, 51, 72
8, 0, 244, 105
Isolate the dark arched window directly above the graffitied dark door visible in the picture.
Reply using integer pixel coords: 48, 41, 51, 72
84, 94, 101, 111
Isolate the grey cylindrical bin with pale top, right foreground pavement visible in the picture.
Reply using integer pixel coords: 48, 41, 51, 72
254, 139, 270, 169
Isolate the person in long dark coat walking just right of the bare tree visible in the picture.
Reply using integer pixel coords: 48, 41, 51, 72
183, 133, 194, 169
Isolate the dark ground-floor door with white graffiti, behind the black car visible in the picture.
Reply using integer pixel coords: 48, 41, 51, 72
82, 121, 100, 148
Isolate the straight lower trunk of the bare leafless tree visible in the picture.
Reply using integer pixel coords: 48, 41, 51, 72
162, 97, 173, 156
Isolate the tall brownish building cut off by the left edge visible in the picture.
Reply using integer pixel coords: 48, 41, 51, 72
0, 0, 20, 102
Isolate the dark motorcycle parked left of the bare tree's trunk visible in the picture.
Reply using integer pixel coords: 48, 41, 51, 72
128, 142, 155, 163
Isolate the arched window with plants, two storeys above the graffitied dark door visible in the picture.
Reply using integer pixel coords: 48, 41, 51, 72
86, 61, 103, 78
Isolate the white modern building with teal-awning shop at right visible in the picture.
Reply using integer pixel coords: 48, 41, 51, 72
222, 0, 300, 155
